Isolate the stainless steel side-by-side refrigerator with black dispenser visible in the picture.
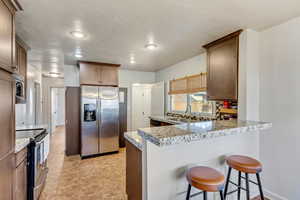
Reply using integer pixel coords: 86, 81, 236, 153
81, 86, 119, 157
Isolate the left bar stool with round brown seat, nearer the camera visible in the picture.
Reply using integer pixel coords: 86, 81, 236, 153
186, 166, 225, 200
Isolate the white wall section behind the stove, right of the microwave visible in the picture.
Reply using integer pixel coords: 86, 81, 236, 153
15, 64, 42, 126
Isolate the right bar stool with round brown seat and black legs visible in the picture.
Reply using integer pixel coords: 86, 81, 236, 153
224, 155, 264, 200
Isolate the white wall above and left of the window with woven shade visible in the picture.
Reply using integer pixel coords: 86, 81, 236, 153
156, 53, 207, 111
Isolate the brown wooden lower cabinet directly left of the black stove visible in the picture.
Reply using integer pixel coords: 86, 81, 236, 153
15, 148, 27, 200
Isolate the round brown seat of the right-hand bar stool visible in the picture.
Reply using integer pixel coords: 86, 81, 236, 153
226, 155, 262, 174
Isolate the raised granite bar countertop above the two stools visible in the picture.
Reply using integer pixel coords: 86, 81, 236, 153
138, 120, 272, 146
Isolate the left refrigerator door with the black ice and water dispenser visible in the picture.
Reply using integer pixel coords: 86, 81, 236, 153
81, 86, 99, 156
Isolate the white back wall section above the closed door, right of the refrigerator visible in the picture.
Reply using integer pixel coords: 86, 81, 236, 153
119, 69, 155, 130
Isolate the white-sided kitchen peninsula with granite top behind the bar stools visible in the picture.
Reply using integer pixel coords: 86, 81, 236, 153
125, 120, 272, 200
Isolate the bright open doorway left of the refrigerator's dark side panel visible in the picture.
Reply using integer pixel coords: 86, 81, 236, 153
50, 88, 65, 133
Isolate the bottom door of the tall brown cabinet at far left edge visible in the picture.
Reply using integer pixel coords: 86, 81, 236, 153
0, 153, 16, 200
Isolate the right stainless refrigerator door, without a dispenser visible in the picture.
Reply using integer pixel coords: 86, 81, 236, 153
99, 87, 119, 153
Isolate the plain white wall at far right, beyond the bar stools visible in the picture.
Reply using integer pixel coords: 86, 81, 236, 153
259, 18, 300, 200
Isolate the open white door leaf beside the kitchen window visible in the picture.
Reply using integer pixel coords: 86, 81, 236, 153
151, 82, 165, 116
